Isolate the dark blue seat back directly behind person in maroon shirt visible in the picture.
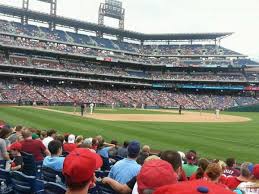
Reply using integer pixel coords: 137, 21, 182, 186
21, 152, 42, 178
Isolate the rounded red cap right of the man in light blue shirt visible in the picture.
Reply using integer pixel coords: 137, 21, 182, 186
137, 159, 177, 194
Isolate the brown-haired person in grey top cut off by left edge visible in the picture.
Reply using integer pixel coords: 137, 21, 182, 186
0, 125, 12, 160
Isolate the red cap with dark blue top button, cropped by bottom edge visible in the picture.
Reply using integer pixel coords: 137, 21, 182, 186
153, 180, 235, 194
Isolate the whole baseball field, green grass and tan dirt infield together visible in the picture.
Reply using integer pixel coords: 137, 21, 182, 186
0, 106, 259, 162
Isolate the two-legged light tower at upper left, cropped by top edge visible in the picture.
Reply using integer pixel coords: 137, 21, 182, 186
21, 0, 57, 29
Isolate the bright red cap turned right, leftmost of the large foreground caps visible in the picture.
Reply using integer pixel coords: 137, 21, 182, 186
63, 148, 103, 183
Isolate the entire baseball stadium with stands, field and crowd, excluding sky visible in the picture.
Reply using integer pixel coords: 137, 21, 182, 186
0, 0, 259, 194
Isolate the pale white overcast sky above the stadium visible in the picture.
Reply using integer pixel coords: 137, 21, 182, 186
0, 0, 259, 61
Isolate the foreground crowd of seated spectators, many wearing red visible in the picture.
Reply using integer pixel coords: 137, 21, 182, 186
0, 123, 259, 194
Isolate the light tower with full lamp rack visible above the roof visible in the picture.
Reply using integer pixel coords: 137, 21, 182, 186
97, 0, 125, 38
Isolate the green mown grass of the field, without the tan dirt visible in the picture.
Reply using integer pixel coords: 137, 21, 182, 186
0, 107, 259, 162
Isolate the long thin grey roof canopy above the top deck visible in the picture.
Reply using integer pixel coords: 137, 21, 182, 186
0, 4, 233, 41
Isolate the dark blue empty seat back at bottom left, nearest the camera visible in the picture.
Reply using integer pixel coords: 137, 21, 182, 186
11, 171, 44, 194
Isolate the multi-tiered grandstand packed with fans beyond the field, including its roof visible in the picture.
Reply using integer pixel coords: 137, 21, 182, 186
0, 2, 259, 109
